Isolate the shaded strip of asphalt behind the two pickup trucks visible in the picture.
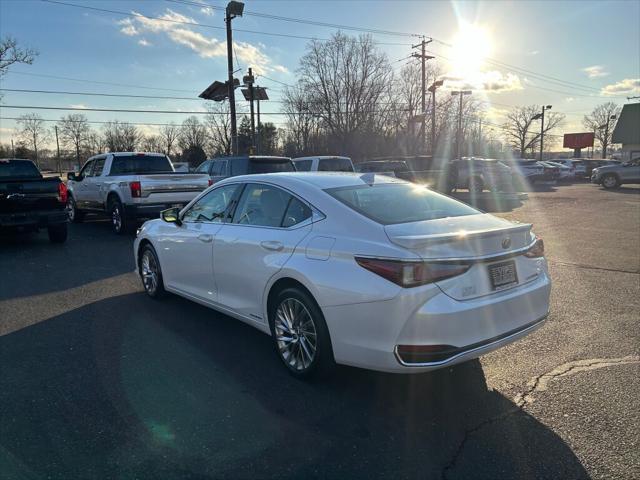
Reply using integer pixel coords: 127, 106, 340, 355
0, 217, 135, 301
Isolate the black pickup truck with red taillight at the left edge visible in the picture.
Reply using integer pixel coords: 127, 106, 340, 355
0, 159, 68, 243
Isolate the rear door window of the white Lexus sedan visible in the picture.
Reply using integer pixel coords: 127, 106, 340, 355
233, 183, 293, 227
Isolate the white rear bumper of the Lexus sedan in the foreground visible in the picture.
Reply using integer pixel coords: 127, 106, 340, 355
322, 270, 551, 373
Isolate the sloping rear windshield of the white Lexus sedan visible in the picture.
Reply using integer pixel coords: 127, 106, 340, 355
325, 183, 480, 225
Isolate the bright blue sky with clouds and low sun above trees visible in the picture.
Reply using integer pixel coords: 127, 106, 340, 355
0, 0, 640, 147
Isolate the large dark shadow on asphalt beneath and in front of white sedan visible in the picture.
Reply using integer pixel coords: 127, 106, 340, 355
0, 293, 588, 479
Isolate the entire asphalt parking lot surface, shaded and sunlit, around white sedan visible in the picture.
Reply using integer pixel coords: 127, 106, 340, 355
0, 184, 640, 479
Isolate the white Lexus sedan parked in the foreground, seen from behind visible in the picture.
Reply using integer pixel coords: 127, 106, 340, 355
134, 173, 551, 377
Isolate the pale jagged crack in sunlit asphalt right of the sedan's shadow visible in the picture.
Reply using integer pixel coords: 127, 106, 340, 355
514, 355, 640, 408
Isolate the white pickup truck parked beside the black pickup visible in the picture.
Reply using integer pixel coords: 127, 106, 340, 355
67, 152, 210, 234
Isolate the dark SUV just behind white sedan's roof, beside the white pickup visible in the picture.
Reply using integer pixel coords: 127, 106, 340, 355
196, 155, 296, 184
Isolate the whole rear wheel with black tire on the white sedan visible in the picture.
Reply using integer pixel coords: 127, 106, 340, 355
269, 288, 335, 379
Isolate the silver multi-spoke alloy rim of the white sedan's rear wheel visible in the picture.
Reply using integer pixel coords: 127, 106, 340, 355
274, 298, 318, 372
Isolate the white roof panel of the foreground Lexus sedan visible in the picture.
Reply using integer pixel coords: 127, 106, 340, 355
216, 172, 409, 190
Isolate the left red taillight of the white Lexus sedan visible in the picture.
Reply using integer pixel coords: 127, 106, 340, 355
355, 257, 471, 288
